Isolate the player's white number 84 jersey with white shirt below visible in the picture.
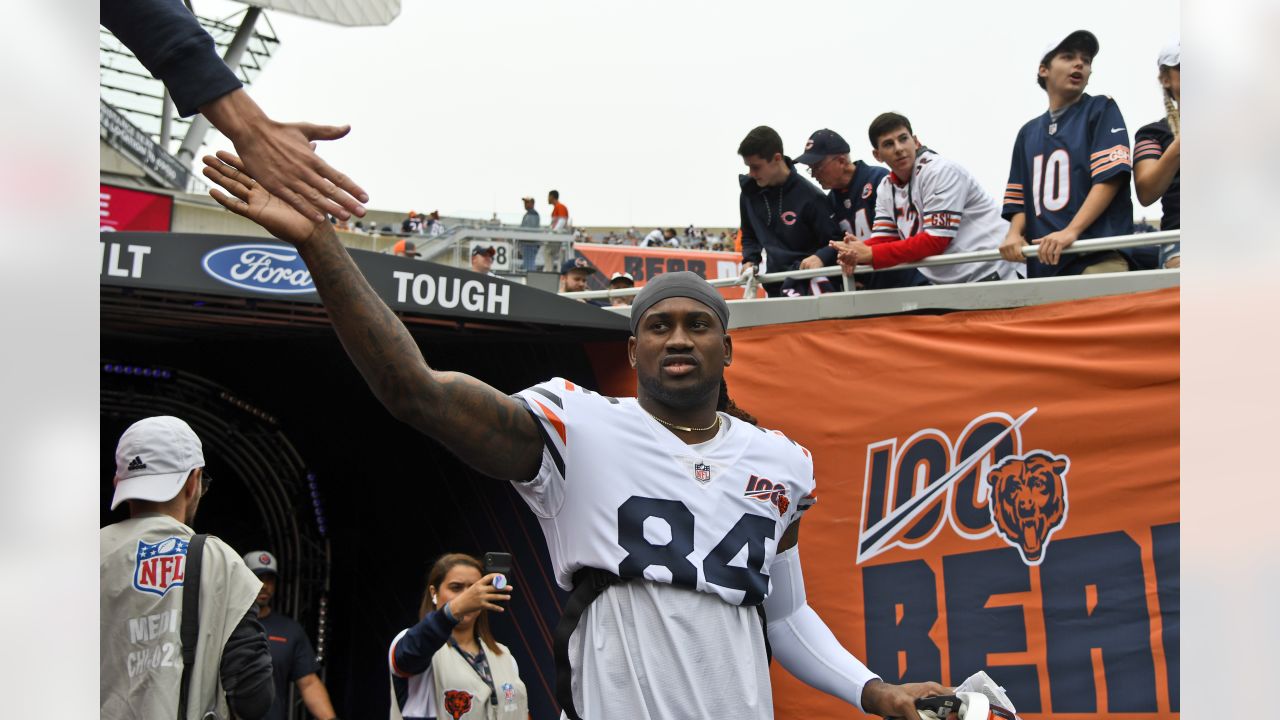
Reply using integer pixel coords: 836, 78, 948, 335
515, 378, 814, 719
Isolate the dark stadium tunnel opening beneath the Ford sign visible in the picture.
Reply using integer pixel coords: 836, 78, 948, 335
100, 323, 625, 719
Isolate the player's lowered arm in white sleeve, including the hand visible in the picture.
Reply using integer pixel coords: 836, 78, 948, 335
764, 520, 948, 717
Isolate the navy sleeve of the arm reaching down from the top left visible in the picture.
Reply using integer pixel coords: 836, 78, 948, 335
99, 0, 241, 118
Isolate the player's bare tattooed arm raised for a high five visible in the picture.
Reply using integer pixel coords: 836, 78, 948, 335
205, 152, 543, 480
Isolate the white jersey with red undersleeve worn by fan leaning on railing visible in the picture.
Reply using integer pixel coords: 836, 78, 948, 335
872, 149, 1016, 284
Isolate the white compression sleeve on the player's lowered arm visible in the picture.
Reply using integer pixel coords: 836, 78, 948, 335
764, 547, 879, 710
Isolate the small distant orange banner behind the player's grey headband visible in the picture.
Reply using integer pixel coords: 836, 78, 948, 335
573, 242, 764, 300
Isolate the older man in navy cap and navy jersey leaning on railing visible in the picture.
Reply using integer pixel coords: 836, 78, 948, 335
795, 128, 929, 290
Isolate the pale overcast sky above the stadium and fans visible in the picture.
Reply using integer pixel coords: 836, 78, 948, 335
195, 0, 1179, 227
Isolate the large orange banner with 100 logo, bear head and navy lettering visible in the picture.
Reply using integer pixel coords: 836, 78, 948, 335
588, 288, 1179, 720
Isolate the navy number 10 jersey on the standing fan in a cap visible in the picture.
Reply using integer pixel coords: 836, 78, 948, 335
1001, 94, 1133, 278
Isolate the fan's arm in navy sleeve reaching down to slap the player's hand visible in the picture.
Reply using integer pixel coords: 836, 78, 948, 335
99, 0, 369, 222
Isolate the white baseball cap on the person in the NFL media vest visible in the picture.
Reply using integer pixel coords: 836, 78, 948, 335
111, 415, 205, 510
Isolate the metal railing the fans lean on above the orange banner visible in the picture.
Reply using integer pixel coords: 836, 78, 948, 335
563, 231, 1181, 300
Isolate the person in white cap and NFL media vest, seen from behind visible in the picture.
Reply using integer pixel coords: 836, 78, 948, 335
99, 415, 274, 720
